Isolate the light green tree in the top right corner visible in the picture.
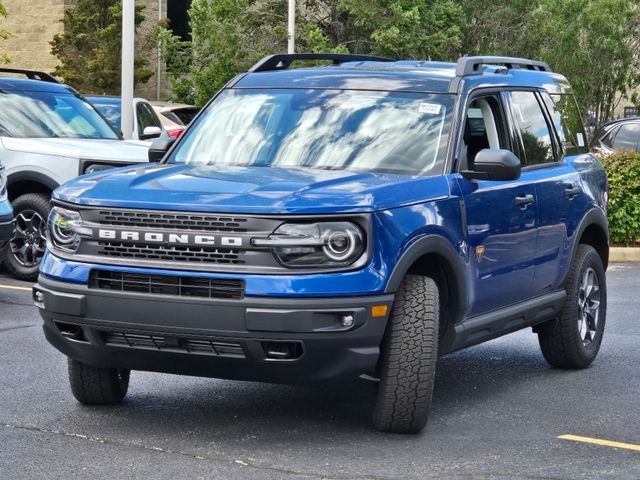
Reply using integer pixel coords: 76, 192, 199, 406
529, 0, 640, 122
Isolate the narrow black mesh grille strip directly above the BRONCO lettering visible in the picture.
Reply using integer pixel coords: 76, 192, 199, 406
98, 210, 247, 233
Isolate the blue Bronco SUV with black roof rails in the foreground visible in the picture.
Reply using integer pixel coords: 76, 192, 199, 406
33, 54, 609, 432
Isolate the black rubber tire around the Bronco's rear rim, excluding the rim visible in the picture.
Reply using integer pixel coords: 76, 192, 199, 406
538, 244, 607, 369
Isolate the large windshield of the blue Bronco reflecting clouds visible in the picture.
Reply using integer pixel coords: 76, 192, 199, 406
169, 89, 453, 175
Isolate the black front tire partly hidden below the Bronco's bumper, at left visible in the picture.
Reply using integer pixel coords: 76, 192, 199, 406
69, 359, 130, 405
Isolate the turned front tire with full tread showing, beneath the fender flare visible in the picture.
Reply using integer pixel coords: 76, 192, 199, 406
373, 275, 439, 433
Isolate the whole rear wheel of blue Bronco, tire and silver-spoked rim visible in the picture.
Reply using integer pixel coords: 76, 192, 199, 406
538, 245, 607, 368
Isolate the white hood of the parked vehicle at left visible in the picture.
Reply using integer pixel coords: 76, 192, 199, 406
2, 137, 150, 162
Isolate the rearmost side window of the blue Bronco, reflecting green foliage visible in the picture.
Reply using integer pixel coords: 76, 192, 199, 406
542, 93, 587, 155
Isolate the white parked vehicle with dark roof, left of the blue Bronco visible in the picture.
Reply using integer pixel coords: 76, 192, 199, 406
0, 68, 149, 279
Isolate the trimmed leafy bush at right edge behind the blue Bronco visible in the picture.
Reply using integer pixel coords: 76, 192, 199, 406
603, 151, 640, 246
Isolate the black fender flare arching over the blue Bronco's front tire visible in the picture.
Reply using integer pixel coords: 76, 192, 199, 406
385, 235, 467, 323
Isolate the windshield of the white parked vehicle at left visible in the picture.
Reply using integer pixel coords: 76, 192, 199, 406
0, 90, 118, 139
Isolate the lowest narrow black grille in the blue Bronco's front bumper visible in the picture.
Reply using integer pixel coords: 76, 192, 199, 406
102, 331, 246, 358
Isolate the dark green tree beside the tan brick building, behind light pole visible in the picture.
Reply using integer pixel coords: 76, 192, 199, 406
50, 0, 153, 94
